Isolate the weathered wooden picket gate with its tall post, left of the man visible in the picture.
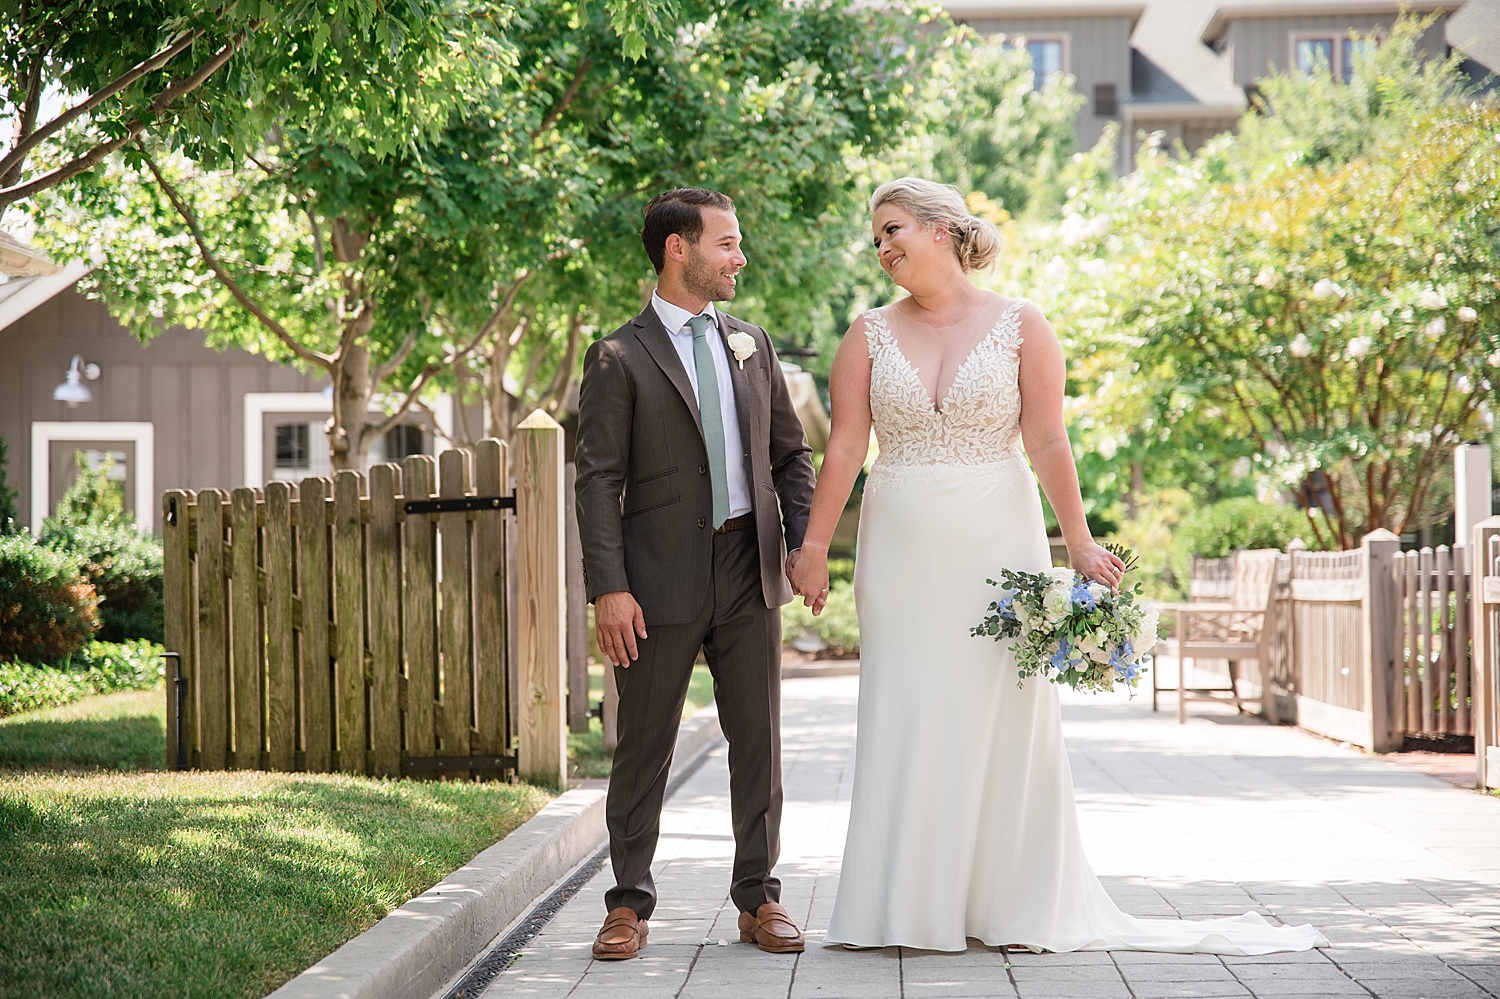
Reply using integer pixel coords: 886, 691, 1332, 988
162, 413, 567, 785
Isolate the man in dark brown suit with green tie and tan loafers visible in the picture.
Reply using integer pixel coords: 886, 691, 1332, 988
578, 188, 813, 960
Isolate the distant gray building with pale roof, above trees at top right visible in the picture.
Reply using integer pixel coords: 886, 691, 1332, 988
944, 0, 1500, 168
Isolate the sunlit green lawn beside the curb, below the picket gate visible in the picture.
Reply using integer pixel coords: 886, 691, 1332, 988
0, 690, 548, 999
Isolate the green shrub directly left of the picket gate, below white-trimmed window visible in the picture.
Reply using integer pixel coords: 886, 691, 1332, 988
42, 522, 164, 642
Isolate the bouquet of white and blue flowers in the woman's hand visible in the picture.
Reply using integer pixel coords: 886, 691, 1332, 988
971, 546, 1157, 690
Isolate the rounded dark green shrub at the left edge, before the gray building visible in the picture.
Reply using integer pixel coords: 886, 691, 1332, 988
0, 534, 99, 663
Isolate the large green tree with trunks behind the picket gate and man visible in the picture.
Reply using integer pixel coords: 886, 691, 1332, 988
29, 0, 920, 468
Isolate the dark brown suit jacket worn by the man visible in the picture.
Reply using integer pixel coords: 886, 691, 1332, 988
576, 305, 813, 626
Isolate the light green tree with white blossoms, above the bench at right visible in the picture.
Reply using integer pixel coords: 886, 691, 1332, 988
1031, 20, 1500, 548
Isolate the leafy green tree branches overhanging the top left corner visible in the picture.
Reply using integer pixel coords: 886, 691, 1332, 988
0, 0, 677, 207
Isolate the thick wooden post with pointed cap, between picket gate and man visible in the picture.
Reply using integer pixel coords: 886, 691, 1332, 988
516, 410, 567, 786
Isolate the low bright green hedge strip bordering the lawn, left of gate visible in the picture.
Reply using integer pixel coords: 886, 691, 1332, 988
0, 641, 165, 716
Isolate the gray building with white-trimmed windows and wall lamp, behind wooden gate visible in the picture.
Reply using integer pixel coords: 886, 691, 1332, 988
0, 261, 453, 531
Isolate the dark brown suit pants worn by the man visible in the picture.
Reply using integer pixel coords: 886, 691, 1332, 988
605, 528, 782, 920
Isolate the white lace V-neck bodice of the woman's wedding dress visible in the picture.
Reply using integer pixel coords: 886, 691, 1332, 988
864, 300, 1026, 470
